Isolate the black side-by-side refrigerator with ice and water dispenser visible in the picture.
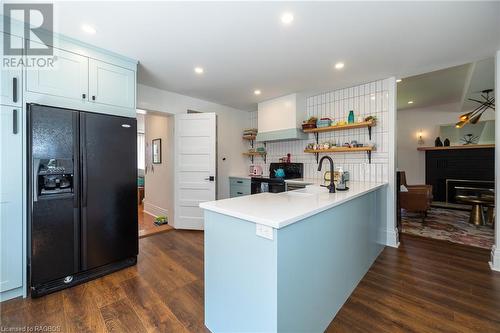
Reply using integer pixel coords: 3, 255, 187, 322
27, 104, 138, 297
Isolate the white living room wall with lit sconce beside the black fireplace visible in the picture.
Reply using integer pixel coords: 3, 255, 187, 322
397, 103, 495, 184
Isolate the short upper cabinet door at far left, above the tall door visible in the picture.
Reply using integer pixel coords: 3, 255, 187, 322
0, 33, 23, 106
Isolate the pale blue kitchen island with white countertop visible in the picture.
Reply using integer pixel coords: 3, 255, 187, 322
200, 182, 387, 332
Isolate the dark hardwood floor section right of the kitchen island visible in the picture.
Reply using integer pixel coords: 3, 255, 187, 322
327, 235, 500, 333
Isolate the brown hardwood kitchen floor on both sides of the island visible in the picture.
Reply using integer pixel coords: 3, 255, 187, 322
1, 231, 500, 332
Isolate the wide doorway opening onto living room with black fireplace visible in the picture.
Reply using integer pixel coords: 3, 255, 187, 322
397, 58, 496, 250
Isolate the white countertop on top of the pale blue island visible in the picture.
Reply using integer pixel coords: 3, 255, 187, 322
200, 182, 387, 229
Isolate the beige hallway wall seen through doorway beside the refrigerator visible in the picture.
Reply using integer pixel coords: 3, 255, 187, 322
144, 113, 173, 217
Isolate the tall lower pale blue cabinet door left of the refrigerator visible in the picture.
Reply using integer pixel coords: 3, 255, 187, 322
0, 106, 23, 292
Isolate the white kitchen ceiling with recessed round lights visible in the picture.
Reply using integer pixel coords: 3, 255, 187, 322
24, 1, 500, 110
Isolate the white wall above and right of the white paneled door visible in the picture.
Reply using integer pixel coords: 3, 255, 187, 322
137, 84, 250, 202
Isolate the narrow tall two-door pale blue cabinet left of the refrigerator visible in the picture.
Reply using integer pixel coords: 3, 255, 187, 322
0, 33, 25, 301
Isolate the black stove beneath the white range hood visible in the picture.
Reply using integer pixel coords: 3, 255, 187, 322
251, 163, 304, 194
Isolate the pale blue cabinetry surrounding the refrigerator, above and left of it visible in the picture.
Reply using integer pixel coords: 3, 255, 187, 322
0, 24, 137, 302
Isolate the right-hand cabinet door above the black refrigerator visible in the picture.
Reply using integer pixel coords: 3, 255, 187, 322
89, 59, 135, 109
